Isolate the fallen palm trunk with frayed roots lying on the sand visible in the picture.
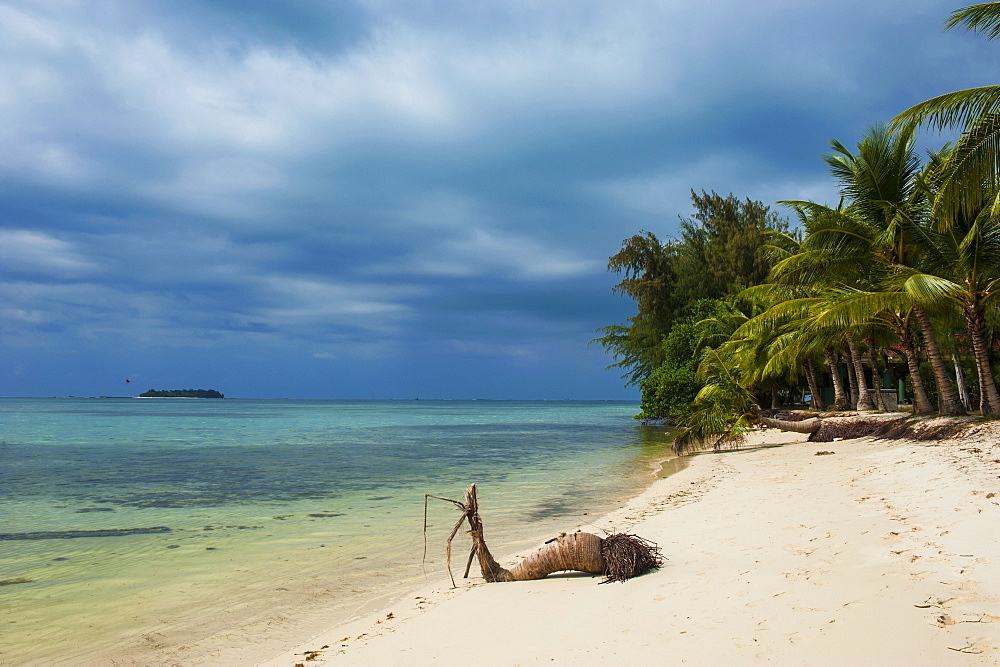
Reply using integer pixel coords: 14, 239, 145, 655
424, 484, 663, 586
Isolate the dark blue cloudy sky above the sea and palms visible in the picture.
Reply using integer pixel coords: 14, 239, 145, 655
0, 0, 1000, 400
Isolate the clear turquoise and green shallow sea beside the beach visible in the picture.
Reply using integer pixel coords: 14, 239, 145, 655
0, 398, 673, 664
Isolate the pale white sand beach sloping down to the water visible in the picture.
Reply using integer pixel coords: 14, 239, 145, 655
263, 426, 1000, 666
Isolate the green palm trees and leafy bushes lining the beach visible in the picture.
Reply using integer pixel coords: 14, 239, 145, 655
598, 2, 1000, 434
